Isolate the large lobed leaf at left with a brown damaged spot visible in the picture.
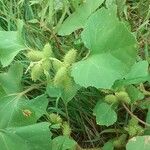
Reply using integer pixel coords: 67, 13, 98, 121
0, 63, 48, 128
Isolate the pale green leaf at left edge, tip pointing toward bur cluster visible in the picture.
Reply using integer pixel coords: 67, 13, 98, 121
0, 31, 27, 67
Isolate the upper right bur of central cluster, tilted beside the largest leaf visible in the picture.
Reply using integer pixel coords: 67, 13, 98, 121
64, 49, 77, 65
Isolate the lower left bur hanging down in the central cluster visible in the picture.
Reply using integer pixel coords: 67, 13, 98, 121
31, 63, 43, 81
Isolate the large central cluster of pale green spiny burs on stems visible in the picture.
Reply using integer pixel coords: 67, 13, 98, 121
27, 44, 77, 89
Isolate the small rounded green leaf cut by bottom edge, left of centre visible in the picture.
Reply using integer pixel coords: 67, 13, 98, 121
52, 136, 76, 150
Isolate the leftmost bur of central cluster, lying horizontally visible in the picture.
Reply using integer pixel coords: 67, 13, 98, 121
27, 50, 44, 62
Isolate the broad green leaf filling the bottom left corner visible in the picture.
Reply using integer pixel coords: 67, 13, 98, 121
0, 123, 51, 150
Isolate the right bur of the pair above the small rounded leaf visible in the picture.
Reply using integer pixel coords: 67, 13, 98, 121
115, 91, 131, 104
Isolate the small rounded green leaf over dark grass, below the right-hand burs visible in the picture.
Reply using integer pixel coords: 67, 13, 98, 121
94, 102, 117, 127
